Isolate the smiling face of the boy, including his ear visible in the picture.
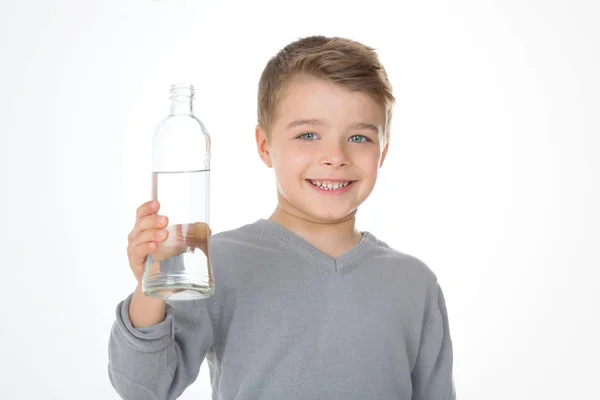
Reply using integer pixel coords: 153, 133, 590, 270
256, 77, 387, 223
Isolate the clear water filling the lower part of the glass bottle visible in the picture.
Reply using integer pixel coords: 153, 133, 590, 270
142, 170, 214, 300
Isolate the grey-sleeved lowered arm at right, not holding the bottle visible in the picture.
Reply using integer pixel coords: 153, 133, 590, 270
411, 283, 456, 400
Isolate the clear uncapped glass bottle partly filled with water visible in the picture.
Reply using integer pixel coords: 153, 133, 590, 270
142, 84, 214, 300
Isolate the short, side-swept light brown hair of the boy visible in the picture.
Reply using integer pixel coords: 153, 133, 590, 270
258, 36, 395, 142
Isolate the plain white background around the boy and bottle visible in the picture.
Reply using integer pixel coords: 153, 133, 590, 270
0, 0, 600, 400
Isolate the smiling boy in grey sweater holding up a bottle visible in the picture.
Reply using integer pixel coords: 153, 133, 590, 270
109, 36, 455, 400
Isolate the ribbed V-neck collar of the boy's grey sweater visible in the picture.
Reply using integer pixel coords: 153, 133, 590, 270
255, 218, 377, 272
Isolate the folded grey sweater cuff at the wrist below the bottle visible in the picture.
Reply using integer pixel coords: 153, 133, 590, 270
116, 293, 175, 352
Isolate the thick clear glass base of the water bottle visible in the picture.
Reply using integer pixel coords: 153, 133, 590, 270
142, 276, 215, 301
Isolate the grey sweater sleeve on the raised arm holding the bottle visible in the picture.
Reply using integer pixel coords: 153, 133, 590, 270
108, 295, 214, 400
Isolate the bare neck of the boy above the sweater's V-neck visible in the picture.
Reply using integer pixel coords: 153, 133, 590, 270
269, 206, 362, 257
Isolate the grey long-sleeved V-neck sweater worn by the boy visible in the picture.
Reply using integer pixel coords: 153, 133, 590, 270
108, 219, 456, 400
